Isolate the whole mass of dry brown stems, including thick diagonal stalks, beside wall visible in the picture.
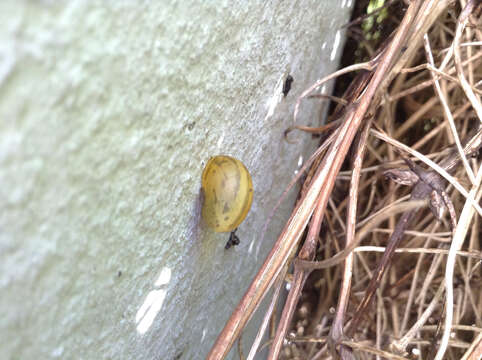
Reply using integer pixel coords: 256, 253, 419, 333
208, 0, 482, 359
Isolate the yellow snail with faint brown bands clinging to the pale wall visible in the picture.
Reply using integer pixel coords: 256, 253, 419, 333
201, 155, 253, 249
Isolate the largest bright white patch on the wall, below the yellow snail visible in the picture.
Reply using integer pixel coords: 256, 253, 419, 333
136, 267, 171, 335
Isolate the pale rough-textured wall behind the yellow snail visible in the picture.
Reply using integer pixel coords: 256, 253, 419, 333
0, 0, 352, 360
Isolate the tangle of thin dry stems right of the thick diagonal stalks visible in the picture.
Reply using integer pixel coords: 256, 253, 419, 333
280, 3, 482, 359
